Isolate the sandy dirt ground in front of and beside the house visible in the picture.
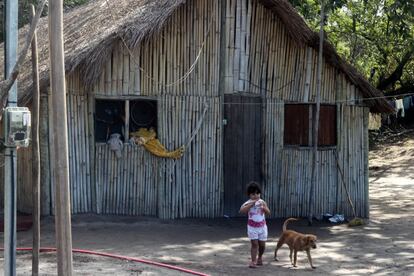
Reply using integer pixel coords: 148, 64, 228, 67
0, 137, 414, 275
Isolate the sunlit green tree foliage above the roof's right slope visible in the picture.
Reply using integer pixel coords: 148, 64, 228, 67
291, 0, 414, 92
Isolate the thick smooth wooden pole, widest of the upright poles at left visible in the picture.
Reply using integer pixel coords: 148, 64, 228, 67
49, 0, 73, 276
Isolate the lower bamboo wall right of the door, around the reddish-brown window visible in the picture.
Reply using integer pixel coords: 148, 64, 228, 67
263, 99, 369, 217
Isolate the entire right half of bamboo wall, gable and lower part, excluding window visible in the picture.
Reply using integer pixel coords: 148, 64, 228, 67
223, 0, 368, 217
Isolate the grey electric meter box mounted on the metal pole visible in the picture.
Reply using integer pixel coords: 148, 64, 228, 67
3, 107, 31, 147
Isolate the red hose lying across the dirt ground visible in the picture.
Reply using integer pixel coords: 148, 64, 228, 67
0, 247, 209, 276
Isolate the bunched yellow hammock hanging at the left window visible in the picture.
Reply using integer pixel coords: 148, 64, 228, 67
130, 128, 184, 159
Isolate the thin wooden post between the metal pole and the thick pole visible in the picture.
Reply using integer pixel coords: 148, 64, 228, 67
30, 5, 40, 276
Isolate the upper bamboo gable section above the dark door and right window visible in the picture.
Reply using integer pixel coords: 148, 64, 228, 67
223, 0, 361, 104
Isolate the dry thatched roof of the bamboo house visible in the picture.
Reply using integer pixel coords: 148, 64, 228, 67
0, 0, 391, 112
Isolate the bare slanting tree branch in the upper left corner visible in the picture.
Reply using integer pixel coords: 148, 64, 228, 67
0, 0, 47, 113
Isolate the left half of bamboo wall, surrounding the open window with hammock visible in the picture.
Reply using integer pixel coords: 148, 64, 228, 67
63, 1, 223, 218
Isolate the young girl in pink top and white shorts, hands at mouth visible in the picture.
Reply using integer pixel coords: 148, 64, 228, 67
240, 182, 270, 268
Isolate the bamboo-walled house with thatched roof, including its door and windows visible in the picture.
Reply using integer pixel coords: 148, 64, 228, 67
0, 0, 390, 218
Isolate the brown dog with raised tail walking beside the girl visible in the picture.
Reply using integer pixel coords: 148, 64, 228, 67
275, 218, 316, 268
